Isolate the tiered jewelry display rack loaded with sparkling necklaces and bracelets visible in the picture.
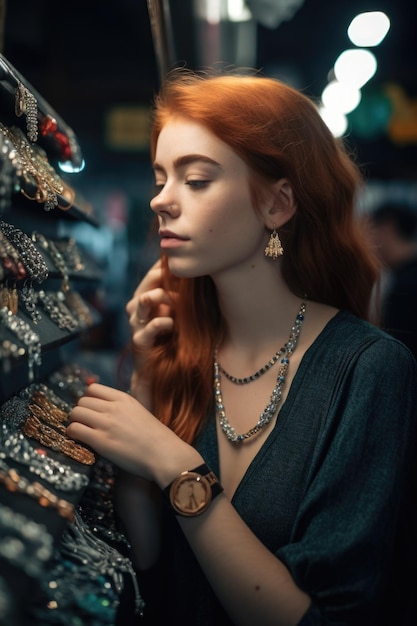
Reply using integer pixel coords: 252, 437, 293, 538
0, 54, 143, 626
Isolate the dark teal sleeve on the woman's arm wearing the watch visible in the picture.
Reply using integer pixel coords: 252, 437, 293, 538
277, 334, 417, 626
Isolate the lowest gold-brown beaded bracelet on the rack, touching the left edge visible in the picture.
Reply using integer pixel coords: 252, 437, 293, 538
0, 459, 74, 521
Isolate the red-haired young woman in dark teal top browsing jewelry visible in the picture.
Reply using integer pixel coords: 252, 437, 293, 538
68, 72, 417, 626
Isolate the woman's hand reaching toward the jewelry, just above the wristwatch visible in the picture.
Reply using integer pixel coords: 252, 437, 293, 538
67, 383, 202, 487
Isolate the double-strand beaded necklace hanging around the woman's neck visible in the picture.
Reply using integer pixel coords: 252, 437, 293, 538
214, 302, 306, 443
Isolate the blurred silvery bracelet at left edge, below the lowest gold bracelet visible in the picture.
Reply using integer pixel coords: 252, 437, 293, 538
0, 504, 53, 578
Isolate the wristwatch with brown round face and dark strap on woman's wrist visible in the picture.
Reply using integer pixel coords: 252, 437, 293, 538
164, 463, 223, 517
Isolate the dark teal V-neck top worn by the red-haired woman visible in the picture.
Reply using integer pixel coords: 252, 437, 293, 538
138, 312, 417, 626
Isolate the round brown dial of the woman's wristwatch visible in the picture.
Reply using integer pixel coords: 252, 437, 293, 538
170, 472, 211, 516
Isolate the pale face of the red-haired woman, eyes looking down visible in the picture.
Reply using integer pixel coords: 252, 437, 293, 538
151, 118, 268, 277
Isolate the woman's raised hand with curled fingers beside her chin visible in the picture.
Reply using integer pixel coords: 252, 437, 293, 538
126, 260, 174, 408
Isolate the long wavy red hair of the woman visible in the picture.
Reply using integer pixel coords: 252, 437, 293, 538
141, 70, 377, 442
